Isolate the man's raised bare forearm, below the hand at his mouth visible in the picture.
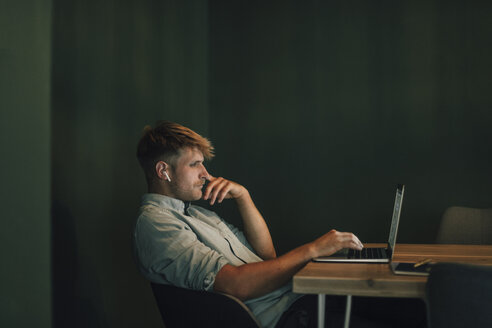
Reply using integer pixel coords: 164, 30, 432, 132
236, 190, 277, 260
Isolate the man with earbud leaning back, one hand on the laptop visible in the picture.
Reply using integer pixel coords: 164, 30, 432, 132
134, 121, 426, 327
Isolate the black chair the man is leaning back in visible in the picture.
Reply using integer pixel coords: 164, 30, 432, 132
151, 283, 260, 328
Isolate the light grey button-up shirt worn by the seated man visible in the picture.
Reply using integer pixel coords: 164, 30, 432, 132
133, 194, 302, 327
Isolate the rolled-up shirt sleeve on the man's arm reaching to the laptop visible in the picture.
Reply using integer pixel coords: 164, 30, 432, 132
134, 218, 228, 290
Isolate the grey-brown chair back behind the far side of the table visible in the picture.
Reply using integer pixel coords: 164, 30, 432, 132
437, 206, 492, 245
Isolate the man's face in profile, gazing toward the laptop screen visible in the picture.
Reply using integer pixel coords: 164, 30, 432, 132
169, 147, 209, 201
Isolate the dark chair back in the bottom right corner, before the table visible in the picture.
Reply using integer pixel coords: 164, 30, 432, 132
426, 263, 492, 328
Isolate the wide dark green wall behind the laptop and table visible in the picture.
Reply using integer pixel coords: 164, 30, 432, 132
209, 0, 492, 251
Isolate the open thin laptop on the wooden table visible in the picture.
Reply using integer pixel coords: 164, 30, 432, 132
313, 184, 405, 263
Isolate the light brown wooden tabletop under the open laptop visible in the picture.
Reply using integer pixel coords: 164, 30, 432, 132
293, 244, 492, 298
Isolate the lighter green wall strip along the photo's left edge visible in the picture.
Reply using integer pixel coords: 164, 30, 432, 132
0, 0, 52, 327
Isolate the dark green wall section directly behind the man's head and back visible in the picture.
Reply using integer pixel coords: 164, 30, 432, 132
52, 0, 208, 327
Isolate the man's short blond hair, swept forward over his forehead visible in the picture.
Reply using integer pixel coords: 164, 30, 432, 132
137, 121, 214, 179
